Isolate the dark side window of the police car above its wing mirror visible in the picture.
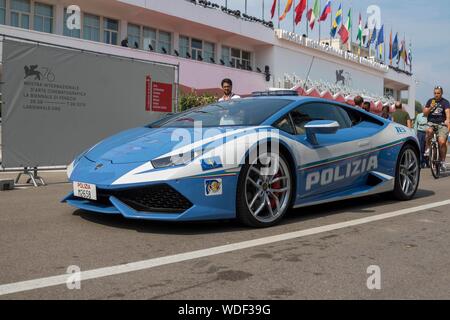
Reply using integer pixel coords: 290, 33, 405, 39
291, 103, 351, 135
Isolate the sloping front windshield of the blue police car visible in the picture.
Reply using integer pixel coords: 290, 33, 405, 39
148, 99, 292, 128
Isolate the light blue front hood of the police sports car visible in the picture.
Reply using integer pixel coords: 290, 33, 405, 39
85, 127, 246, 164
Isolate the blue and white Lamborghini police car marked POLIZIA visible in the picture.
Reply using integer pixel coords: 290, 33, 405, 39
63, 94, 420, 227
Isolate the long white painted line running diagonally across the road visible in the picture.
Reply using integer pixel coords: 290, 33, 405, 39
0, 200, 450, 296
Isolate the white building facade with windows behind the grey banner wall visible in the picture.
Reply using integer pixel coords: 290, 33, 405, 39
0, 0, 415, 115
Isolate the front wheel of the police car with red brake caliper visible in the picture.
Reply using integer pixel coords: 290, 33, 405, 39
236, 151, 294, 228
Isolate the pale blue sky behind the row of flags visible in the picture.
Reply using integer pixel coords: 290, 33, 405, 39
213, 0, 450, 104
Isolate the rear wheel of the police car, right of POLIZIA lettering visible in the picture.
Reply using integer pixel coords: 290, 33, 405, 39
392, 144, 420, 201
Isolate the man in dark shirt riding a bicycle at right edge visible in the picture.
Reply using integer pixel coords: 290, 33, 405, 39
423, 86, 450, 171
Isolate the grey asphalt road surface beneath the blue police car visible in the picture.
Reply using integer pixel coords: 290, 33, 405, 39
0, 170, 450, 299
